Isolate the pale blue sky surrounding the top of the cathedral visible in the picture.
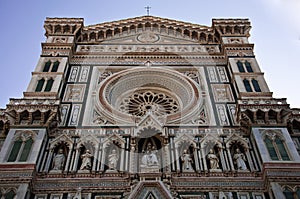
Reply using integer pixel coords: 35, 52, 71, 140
0, 0, 300, 108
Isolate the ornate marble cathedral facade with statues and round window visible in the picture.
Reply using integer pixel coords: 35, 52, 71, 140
0, 16, 300, 199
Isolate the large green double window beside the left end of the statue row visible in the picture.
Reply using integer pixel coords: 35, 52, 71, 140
7, 132, 33, 162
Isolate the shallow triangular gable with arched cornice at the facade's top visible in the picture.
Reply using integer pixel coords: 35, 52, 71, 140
77, 16, 219, 44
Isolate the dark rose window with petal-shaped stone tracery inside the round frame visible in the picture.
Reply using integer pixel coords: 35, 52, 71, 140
119, 91, 179, 117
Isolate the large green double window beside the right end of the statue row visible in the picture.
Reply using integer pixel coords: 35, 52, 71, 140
264, 133, 290, 161
